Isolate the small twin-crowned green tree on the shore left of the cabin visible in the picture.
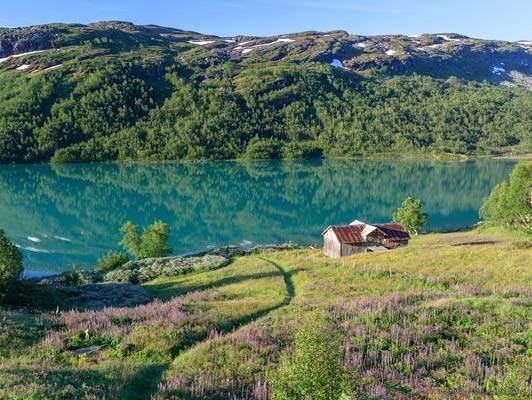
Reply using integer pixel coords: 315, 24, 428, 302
120, 220, 172, 260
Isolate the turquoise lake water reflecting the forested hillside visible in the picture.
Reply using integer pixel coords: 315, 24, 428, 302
0, 160, 514, 273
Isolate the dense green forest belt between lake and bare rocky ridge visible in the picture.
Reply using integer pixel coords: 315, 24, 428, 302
0, 60, 532, 162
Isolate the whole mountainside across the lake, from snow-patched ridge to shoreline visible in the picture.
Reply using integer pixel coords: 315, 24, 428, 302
0, 22, 532, 163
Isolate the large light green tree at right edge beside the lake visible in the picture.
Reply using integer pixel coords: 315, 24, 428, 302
480, 161, 532, 233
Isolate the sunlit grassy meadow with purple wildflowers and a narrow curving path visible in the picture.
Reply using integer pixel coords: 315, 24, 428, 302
0, 230, 532, 400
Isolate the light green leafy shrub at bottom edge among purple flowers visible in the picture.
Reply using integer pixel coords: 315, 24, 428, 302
272, 316, 346, 400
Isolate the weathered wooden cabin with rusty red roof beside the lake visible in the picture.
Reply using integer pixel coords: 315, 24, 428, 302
322, 221, 410, 257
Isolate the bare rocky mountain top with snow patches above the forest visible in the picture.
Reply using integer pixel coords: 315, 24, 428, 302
0, 22, 532, 88
